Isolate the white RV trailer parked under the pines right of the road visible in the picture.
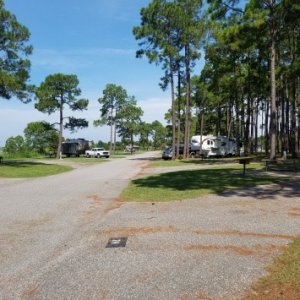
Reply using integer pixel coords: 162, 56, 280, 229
191, 135, 237, 157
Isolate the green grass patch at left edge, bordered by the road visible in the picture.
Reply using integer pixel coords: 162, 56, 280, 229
0, 160, 73, 178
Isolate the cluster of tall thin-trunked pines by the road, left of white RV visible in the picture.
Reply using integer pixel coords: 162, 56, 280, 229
133, 0, 206, 159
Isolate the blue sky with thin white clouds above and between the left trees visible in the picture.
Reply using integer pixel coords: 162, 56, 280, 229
0, 0, 203, 146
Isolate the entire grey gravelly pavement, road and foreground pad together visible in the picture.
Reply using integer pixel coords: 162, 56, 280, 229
0, 153, 300, 300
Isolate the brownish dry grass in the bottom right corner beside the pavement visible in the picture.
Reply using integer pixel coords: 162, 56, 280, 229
244, 237, 300, 300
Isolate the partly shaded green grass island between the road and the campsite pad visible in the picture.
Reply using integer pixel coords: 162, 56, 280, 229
121, 164, 283, 202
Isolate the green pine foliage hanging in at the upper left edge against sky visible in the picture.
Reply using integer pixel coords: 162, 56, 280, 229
0, 0, 32, 102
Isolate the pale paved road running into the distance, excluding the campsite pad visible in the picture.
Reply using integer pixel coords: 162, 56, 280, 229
0, 153, 154, 299
